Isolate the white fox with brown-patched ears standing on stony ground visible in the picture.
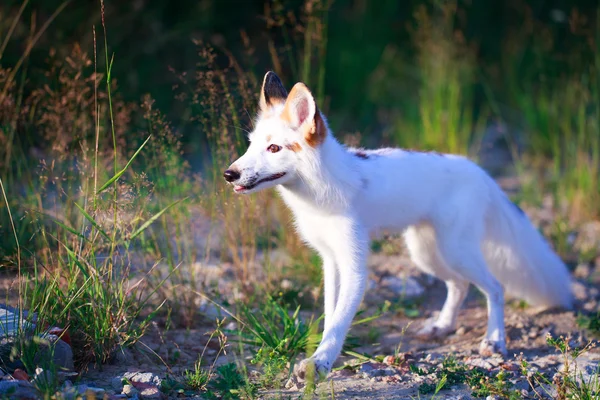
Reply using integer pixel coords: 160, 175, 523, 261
224, 72, 572, 378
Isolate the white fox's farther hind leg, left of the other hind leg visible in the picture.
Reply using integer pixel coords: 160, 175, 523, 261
404, 225, 469, 339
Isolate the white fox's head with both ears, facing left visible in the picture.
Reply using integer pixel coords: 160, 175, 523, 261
223, 72, 327, 193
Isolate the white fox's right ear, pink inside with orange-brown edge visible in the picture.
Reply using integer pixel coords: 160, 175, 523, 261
281, 82, 327, 147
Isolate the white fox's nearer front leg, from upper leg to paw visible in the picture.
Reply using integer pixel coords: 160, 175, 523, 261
297, 218, 368, 379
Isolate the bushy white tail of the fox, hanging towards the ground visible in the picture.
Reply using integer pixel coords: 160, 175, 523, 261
483, 178, 573, 308
